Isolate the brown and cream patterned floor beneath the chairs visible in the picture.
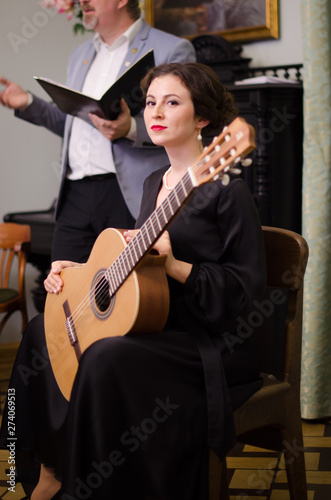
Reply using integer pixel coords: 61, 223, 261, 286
0, 344, 331, 500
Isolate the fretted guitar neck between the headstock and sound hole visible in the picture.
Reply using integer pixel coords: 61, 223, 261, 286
105, 170, 197, 295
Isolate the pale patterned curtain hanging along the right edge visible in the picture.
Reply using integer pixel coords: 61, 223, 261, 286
301, 0, 331, 419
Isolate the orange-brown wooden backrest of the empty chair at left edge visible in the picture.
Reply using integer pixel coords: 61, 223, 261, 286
0, 222, 31, 293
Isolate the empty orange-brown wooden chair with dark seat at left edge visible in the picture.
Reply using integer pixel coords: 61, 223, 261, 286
0, 222, 31, 333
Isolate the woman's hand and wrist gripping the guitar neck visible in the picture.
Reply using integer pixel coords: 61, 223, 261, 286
124, 229, 192, 283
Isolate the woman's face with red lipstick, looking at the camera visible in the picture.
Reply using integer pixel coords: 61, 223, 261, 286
144, 74, 199, 148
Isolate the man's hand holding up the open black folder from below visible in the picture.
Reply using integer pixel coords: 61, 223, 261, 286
89, 98, 131, 141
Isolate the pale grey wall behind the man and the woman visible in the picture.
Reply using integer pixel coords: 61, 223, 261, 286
0, 0, 302, 342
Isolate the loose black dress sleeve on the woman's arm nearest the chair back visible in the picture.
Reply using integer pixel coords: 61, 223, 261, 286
178, 180, 266, 333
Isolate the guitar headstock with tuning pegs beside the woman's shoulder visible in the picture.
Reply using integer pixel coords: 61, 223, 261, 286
191, 117, 255, 186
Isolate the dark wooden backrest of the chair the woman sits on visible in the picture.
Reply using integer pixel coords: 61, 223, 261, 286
263, 226, 309, 390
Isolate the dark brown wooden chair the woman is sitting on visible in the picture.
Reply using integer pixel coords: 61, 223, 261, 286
209, 227, 308, 500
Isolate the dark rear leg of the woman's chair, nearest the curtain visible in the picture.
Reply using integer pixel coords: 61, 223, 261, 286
282, 419, 308, 500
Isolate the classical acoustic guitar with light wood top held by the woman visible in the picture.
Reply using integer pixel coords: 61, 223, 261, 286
45, 118, 255, 400
